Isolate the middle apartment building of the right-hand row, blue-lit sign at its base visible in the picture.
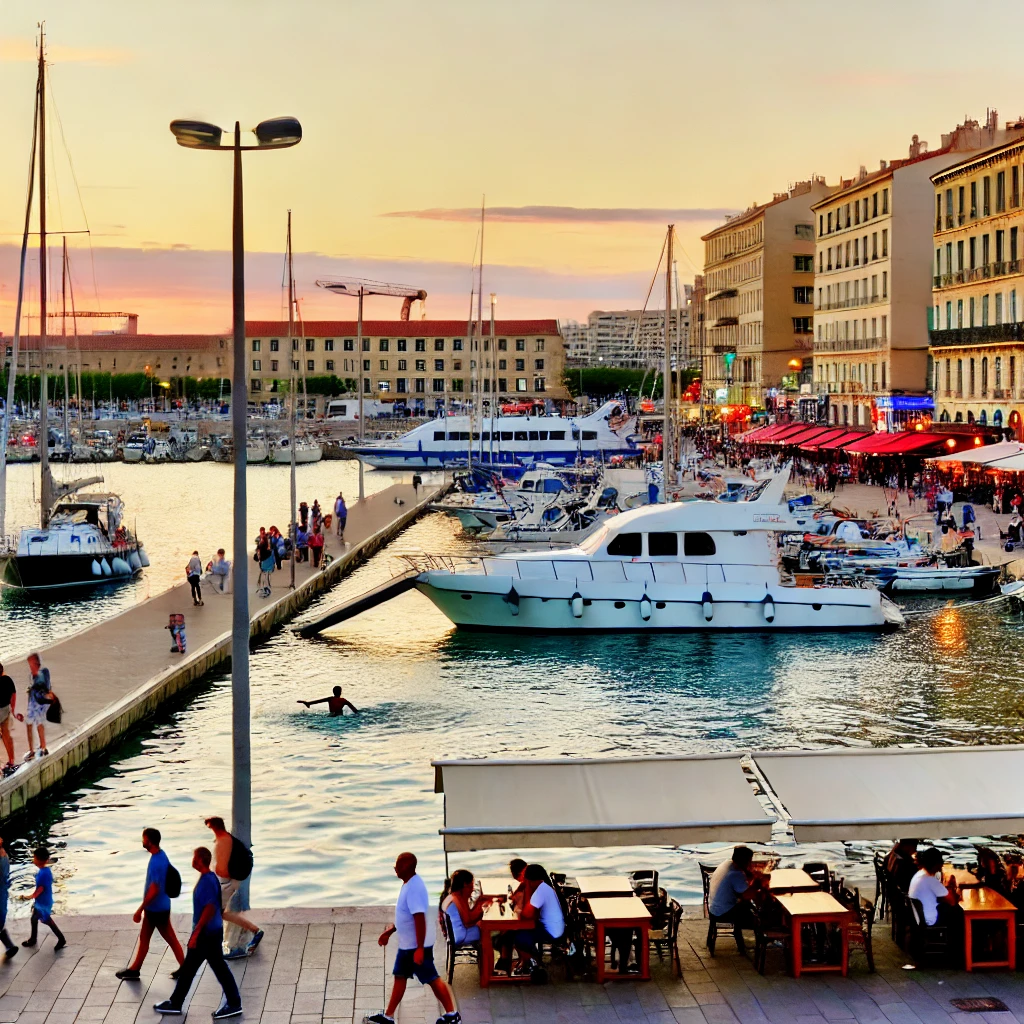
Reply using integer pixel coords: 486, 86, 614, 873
815, 111, 1015, 430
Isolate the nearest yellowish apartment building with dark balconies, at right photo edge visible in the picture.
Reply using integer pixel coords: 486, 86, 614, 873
930, 133, 1024, 439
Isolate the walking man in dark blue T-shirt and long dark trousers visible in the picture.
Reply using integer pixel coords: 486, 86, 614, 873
153, 846, 242, 1021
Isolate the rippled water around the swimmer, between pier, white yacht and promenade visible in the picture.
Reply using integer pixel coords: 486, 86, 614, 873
5, 464, 1024, 912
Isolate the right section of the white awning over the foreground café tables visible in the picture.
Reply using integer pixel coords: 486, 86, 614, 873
754, 745, 1024, 843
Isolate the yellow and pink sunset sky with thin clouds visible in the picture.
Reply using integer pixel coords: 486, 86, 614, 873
0, 0, 1024, 334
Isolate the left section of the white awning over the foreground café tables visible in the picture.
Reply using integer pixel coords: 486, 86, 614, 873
433, 754, 775, 851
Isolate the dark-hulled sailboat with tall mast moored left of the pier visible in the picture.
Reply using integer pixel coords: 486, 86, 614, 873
0, 26, 150, 593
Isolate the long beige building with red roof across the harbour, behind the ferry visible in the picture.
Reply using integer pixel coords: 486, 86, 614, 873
246, 319, 566, 411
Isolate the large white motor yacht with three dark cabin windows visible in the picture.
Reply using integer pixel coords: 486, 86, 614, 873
404, 467, 904, 634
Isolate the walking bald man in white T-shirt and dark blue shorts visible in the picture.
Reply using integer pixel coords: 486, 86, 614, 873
364, 853, 462, 1024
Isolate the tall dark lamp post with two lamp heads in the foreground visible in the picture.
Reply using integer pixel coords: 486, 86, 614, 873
170, 118, 302, 942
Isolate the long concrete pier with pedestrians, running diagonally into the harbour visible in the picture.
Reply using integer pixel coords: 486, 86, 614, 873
0, 483, 445, 818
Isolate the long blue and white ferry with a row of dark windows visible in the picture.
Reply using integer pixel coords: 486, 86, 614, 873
351, 401, 640, 469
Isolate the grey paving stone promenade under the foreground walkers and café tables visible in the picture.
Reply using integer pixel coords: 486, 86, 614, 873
0, 907, 1024, 1024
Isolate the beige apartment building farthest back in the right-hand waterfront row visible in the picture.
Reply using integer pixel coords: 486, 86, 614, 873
700, 177, 833, 410
